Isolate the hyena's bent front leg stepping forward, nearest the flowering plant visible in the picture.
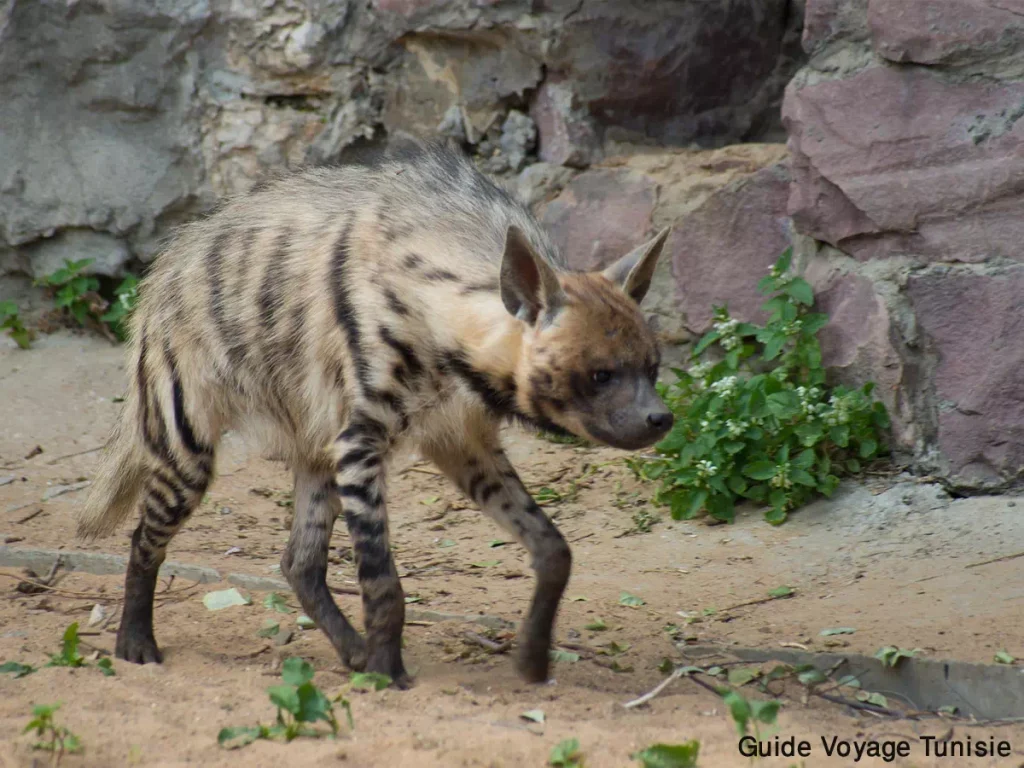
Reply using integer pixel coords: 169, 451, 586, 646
427, 444, 572, 683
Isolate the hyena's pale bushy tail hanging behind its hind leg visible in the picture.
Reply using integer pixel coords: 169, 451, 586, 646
77, 392, 146, 539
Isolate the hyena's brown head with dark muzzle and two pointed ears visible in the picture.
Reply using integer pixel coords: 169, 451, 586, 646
500, 227, 673, 450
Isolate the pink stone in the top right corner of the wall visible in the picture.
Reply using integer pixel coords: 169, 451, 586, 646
867, 0, 1024, 65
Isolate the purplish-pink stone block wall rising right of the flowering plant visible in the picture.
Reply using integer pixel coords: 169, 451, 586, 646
783, 0, 1024, 487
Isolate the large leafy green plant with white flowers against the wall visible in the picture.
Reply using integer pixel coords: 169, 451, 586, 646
631, 249, 889, 524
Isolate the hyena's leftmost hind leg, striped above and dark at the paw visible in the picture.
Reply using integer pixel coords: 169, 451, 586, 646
115, 460, 213, 664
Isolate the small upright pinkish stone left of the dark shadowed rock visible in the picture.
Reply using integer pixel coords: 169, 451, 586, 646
529, 78, 599, 168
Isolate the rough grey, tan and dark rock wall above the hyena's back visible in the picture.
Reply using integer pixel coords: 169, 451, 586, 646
0, 0, 802, 275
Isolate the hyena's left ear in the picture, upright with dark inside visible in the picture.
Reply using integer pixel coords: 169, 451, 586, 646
499, 226, 563, 325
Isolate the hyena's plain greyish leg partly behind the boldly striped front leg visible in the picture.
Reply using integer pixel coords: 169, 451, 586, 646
281, 468, 367, 671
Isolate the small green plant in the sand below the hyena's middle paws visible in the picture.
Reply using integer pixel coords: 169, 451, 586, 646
217, 657, 352, 750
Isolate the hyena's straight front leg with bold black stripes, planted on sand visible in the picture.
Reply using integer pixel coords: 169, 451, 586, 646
335, 417, 413, 688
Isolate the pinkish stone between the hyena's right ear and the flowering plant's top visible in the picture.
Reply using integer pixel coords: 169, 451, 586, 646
666, 164, 790, 334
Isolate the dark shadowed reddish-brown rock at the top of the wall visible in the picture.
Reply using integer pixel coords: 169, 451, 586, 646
542, 0, 791, 143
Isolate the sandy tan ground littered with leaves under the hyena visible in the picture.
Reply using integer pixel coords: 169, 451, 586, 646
0, 333, 1024, 767
